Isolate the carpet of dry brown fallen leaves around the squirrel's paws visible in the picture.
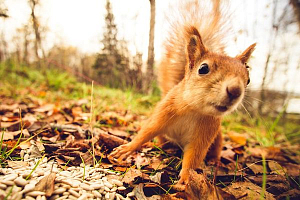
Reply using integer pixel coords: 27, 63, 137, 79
0, 98, 300, 199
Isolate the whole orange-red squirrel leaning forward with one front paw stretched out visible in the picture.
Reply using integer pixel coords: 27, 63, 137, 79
111, 0, 256, 184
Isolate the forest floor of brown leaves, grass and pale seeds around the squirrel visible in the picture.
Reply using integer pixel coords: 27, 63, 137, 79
0, 64, 300, 199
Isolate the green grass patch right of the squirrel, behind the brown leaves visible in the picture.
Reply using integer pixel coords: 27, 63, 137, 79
222, 112, 300, 147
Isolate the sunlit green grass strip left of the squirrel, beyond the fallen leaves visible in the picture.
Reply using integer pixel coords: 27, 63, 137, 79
0, 61, 160, 114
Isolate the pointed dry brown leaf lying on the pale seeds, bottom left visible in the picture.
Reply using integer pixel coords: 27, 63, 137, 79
34, 172, 56, 197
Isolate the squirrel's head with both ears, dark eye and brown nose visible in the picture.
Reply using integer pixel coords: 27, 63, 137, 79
183, 28, 256, 116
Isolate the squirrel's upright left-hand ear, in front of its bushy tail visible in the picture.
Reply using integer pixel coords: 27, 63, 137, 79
187, 27, 206, 69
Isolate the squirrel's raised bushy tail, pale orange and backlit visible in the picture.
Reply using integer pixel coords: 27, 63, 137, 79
158, 0, 230, 96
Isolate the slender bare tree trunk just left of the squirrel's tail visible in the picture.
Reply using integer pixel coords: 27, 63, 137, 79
143, 0, 155, 92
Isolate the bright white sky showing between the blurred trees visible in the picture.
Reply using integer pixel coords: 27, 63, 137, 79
0, 0, 300, 93
